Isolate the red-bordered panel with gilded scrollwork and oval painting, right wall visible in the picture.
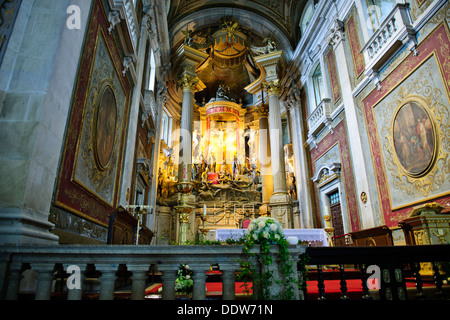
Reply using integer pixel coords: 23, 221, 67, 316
363, 24, 450, 226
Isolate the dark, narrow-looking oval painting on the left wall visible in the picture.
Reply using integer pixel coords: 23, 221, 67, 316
96, 86, 117, 169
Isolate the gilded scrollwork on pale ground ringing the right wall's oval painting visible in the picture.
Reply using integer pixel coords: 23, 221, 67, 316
380, 63, 450, 197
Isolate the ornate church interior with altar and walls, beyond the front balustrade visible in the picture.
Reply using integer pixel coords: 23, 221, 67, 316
0, 0, 450, 298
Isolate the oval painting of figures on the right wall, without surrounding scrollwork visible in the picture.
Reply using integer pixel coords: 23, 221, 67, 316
393, 101, 436, 176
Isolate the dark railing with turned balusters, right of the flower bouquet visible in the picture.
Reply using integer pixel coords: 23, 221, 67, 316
305, 245, 450, 300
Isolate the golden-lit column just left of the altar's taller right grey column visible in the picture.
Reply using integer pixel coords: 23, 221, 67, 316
256, 104, 273, 215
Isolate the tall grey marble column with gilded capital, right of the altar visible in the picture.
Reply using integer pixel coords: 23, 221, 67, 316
264, 79, 292, 228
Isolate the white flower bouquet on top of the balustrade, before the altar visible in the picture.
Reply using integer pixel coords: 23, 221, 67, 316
248, 217, 284, 244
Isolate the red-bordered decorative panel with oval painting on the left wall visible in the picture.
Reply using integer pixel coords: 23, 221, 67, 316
55, 1, 130, 225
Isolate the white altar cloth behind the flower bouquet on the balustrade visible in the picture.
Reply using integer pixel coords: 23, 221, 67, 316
215, 229, 328, 247
